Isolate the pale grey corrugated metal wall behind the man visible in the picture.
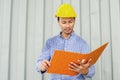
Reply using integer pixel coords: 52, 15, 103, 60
0, 0, 120, 80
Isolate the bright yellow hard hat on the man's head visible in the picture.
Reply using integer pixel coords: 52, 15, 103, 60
55, 3, 76, 18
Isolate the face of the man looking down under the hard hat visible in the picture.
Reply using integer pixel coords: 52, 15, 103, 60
58, 18, 75, 35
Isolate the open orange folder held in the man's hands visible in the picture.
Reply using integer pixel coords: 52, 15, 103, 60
47, 43, 108, 76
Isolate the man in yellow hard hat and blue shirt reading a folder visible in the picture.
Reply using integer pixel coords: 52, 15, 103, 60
37, 4, 95, 80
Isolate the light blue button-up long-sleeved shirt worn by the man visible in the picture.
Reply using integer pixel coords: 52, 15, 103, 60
37, 32, 95, 80
